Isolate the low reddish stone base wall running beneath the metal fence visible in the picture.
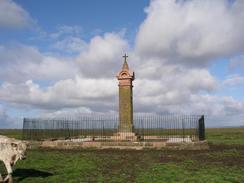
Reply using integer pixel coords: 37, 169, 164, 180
35, 139, 209, 151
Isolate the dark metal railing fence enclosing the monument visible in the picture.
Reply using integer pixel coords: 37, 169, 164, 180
23, 115, 205, 141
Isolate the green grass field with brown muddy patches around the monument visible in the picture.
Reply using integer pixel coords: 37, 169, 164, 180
0, 128, 244, 183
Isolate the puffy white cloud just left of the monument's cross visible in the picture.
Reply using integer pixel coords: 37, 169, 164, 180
77, 33, 128, 78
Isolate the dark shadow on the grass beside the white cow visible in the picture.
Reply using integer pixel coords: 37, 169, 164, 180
13, 168, 53, 181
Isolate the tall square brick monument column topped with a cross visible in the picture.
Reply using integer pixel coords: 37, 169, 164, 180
117, 54, 134, 133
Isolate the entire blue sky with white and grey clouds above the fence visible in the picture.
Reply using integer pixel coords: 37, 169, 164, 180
0, 0, 244, 128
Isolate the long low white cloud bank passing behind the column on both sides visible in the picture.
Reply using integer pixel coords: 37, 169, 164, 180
0, 64, 216, 112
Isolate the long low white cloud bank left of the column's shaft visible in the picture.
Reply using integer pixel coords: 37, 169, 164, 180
0, 76, 116, 110
